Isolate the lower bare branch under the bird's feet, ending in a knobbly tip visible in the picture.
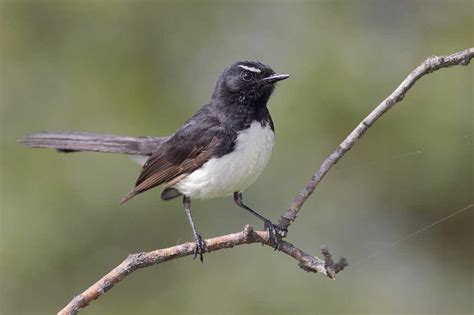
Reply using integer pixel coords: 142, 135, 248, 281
58, 225, 347, 315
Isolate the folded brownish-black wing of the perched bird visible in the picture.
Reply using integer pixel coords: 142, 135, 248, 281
120, 111, 221, 203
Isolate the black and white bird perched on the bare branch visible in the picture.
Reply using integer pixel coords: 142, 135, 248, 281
22, 61, 289, 261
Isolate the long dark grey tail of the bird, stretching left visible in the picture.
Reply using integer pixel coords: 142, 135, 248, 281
18, 131, 167, 155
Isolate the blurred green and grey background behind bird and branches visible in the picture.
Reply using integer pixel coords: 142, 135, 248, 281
0, 0, 474, 314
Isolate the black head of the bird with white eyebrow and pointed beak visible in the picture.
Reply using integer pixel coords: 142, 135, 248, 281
212, 61, 289, 104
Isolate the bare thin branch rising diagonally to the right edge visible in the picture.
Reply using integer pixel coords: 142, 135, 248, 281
278, 48, 474, 235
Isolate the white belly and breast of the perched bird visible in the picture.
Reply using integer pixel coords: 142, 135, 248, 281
174, 122, 275, 199
